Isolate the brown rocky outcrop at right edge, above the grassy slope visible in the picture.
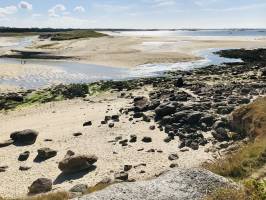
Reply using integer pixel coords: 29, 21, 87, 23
231, 97, 266, 138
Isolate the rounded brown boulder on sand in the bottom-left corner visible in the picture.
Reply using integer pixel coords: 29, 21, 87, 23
29, 178, 53, 194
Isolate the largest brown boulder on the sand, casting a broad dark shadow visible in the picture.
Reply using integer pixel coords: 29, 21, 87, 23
58, 151, 98, 173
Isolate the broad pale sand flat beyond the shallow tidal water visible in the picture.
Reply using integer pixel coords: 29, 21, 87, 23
27, 36, 266, 68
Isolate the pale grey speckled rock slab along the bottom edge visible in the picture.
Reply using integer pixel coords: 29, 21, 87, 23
76, 168, 236, 200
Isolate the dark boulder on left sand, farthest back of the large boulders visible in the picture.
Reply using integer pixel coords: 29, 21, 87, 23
10, 129, 39, 145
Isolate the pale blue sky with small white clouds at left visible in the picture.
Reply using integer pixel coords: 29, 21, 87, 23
0, 0, 266, 29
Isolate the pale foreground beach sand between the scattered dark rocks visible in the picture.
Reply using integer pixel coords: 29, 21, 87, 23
0, 88, 211, 197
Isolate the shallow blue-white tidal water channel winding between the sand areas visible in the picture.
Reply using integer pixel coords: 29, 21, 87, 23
0, 49, 241, 89
